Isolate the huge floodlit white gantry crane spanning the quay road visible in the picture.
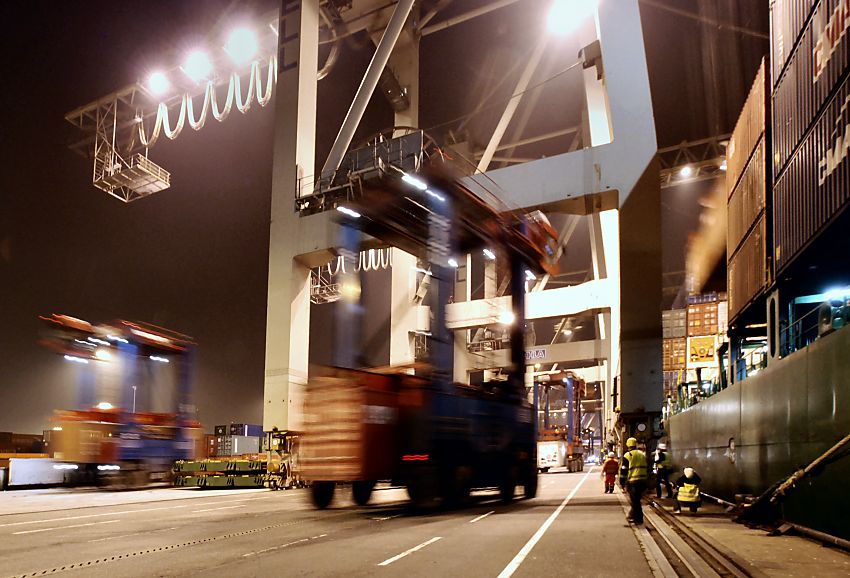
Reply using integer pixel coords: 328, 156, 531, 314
66, 0, 662, 442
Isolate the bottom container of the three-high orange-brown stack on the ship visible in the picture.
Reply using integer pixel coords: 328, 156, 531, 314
727, 216, 770, 321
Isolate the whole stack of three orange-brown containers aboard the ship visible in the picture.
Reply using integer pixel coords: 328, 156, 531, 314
724, 61, 772, 320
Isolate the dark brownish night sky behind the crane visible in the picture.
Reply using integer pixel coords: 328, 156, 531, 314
0, 0, 767, 432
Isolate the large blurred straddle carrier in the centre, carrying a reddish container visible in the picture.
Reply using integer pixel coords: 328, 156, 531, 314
300, 156, 557, 508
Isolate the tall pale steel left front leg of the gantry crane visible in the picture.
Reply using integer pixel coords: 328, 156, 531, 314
263, 0, 322, 431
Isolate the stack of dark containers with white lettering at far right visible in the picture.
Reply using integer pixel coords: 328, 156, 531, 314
771, 0, 850, 272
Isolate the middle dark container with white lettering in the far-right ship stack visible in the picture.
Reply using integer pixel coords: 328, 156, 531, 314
772, 0, 850, 177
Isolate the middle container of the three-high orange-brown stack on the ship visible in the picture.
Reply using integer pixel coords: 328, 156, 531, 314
726, 138, 767, 257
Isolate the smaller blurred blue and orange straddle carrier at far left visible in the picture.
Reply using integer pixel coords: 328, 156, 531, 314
41, 314, 205, 489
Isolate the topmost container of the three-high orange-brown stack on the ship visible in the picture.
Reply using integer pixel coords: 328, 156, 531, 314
726, 59, 770, 197
